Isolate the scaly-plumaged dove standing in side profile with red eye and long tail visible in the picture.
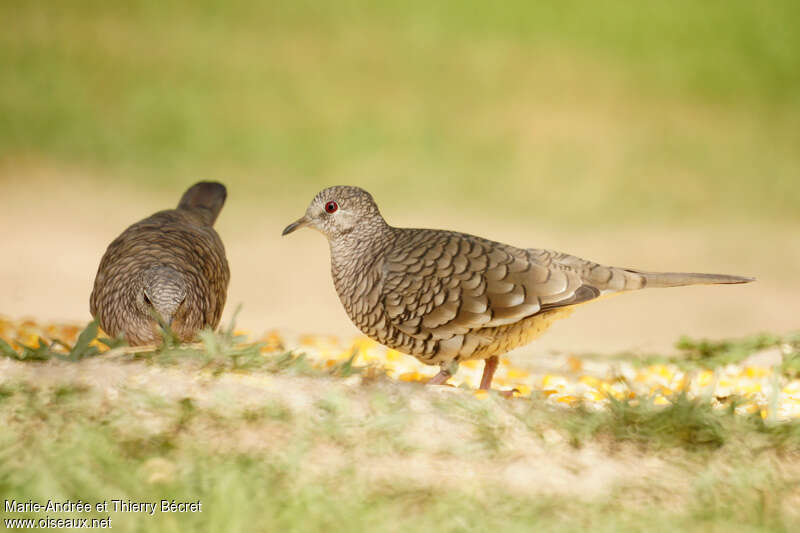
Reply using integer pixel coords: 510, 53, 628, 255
284, 186, 752, 388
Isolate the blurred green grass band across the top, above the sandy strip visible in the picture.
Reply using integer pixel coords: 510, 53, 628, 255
0, 0, 800, 225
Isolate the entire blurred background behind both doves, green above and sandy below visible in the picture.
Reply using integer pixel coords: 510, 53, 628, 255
0, 0, 800, 351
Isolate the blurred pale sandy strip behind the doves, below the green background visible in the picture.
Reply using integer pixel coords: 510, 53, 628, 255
0, 173, 800, 362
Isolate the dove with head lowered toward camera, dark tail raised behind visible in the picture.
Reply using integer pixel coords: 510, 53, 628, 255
90, 182, 230, 345
